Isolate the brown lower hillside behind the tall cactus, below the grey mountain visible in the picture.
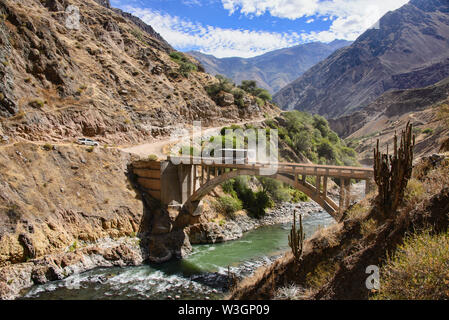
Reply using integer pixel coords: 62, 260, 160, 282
329, 77, 449, 165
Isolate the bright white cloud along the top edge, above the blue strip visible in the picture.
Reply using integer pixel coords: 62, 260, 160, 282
221, 0, 408, 41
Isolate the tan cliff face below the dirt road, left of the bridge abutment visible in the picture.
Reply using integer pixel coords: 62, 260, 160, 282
0, 143, 146, 267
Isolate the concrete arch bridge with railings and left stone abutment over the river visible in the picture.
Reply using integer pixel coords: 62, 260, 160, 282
132, 157, 373, 220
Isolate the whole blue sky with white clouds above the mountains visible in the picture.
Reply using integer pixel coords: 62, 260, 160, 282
111, 0, 408, 58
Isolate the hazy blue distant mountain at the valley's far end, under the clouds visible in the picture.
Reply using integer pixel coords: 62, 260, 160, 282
189, 40, 351, 93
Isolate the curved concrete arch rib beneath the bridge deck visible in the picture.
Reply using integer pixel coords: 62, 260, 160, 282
183, 169, 341, 220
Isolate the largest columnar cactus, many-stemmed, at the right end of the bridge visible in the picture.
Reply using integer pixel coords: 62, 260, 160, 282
374, 122, 415, 218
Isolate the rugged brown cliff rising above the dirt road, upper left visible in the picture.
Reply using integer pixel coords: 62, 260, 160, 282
0, 0, 273, 144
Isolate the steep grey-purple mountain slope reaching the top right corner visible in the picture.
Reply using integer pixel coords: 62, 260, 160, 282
274, 0, 449, 118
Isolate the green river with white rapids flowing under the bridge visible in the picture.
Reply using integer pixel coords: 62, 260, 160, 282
22, 212, 335, 300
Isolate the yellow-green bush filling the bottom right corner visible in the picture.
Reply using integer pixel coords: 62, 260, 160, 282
374, 231, 449, 300
